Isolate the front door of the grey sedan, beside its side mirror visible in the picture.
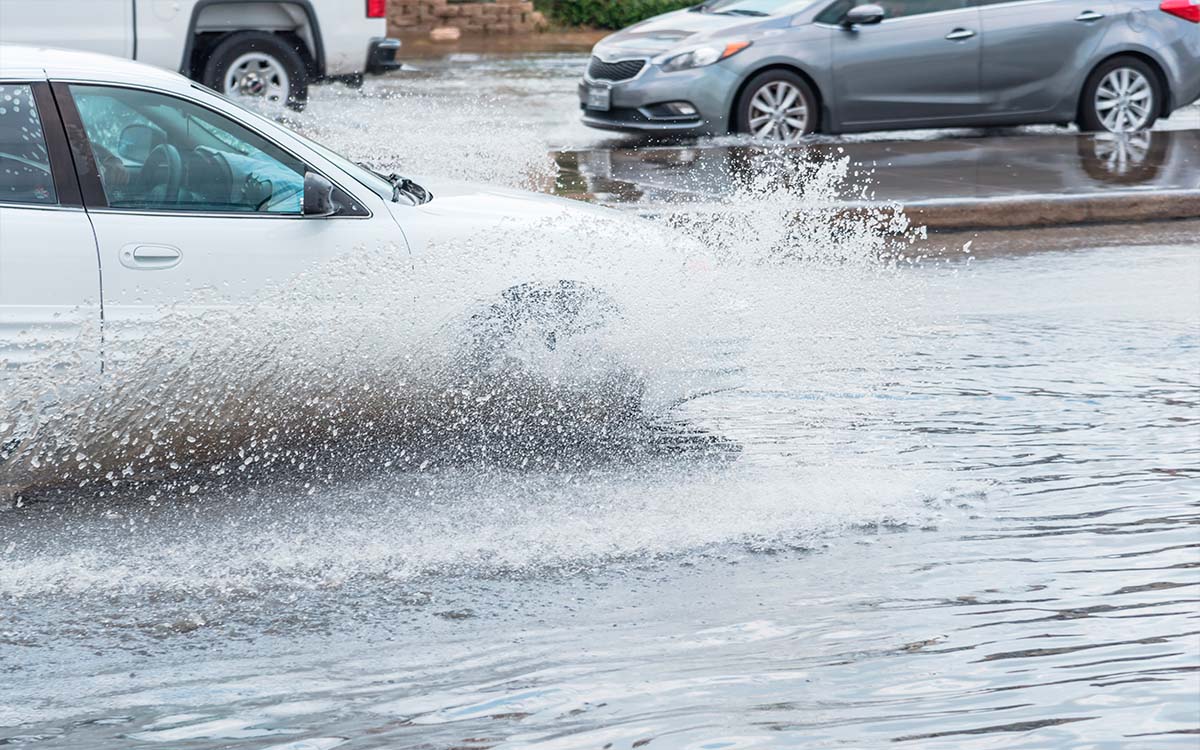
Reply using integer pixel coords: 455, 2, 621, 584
833, 0, 980, 130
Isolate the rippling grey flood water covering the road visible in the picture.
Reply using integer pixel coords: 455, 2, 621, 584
0, 49, 1200, 750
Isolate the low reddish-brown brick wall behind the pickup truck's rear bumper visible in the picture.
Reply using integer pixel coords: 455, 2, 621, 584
388, 0, 546, 35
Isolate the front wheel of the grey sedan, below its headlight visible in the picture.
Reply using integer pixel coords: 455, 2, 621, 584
734, 70, 821, 143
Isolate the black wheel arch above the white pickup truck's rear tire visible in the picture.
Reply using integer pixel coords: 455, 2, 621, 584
179, 0, 325, 79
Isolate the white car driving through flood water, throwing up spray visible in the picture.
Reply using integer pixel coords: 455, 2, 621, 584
0, 46, 715, 488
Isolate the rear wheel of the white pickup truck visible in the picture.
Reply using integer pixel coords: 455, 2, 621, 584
200, 31, 308, 110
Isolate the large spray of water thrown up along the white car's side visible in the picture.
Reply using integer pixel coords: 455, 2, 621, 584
2, 86, 944, 609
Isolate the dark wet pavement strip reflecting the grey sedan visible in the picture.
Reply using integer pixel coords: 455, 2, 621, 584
556, 131, 1200, 205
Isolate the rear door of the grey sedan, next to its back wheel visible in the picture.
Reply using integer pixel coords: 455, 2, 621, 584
976, 0, 1114, 115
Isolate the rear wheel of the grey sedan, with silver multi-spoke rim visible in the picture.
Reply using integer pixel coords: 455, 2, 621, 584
1079, 56, 1163, 133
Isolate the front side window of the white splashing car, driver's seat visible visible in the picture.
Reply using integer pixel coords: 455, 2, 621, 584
71, 84, 305, 215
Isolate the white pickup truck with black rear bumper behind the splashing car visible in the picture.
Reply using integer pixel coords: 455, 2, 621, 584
0, 0, 400, 109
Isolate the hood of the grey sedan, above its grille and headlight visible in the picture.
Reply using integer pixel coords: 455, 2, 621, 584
593, 11, 778, 58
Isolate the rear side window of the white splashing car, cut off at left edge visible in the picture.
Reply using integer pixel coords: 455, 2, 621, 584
0, 84, 59, 205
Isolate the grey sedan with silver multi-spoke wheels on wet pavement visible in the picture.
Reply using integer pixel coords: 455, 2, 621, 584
580, 0, 1200, 143
